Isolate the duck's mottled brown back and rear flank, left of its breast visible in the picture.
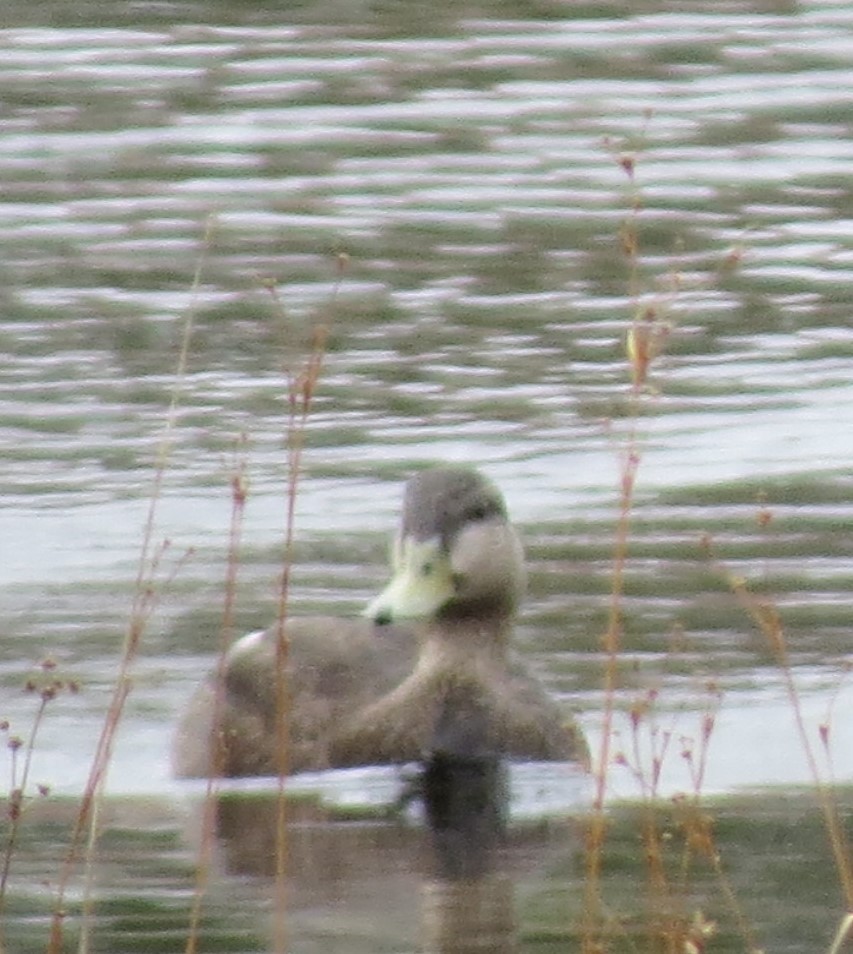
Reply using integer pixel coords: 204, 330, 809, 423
173, 616, 416, 778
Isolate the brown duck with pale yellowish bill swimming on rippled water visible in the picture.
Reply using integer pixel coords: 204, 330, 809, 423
173, 464, 589, 777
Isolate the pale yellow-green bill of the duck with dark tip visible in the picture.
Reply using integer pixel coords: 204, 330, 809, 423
364, 537, 454, 623
